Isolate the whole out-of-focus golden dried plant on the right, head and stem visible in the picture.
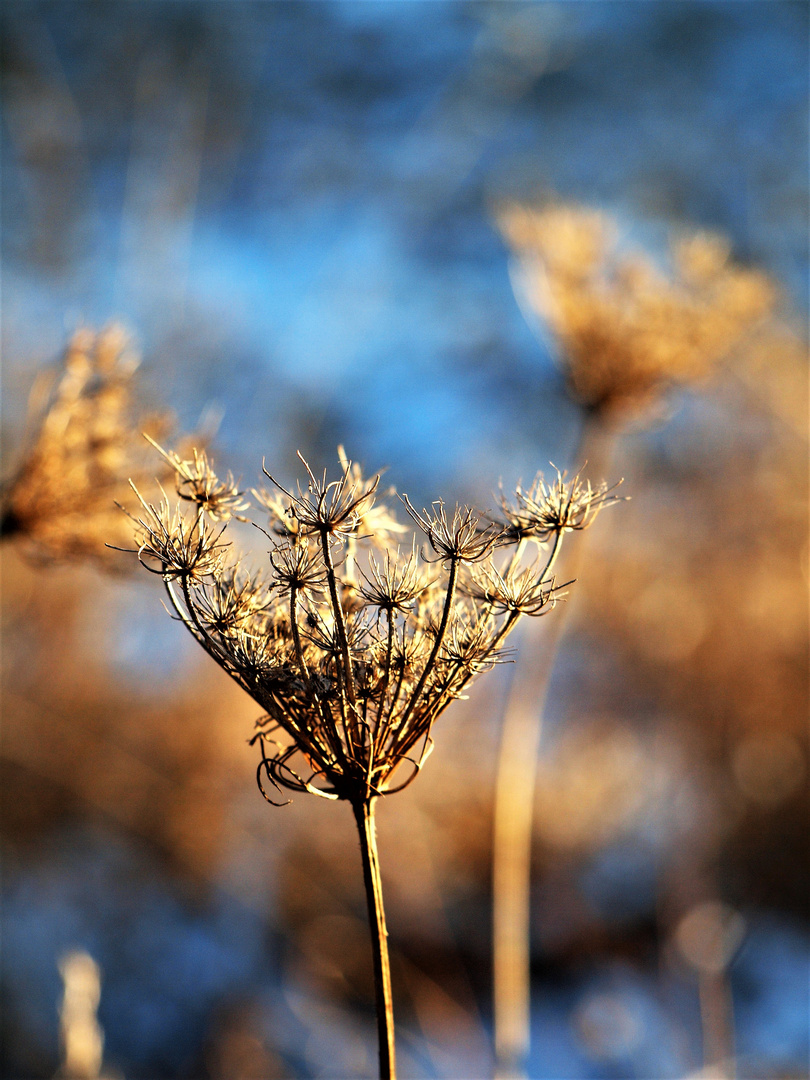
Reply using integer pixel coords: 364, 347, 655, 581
492, 202, 774, 1077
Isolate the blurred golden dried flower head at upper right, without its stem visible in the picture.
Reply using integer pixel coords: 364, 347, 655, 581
500, 204, 774, 417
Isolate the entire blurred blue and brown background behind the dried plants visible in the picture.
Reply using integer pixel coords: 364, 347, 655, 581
0, 0, 808, 1080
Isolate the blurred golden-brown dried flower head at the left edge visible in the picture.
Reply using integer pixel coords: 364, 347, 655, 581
0, 326, 193, 568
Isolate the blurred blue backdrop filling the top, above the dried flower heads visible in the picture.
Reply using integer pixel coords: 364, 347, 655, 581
3, 0, 807, 492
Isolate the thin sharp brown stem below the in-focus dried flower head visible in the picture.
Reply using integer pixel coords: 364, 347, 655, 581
352, 797, 396, 1080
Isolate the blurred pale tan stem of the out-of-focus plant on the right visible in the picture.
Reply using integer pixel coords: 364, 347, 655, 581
492, 414, 610, 1080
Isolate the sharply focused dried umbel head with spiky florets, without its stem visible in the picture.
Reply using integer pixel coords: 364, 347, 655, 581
123, 442, 610, 806
